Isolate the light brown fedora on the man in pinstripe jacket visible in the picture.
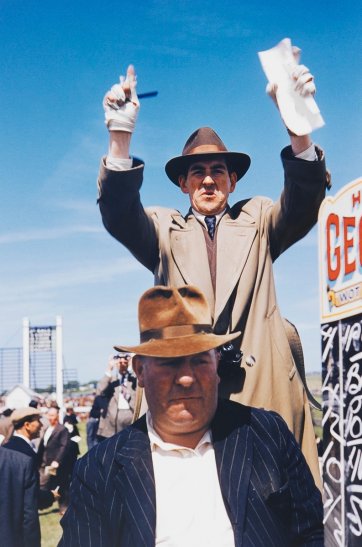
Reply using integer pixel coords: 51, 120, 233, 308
114, 285, 240, 357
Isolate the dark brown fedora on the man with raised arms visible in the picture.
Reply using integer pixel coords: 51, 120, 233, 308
165, 127, 251, 186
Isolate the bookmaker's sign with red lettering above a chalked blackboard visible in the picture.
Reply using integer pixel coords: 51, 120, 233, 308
319, 179, 362, 547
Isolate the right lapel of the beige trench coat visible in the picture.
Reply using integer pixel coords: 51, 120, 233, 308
214, 213, 257, 323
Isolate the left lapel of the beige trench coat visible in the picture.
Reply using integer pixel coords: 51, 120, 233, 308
170, 214, 215, 312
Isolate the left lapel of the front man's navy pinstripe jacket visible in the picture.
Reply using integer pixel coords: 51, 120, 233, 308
115, 426, 156, 547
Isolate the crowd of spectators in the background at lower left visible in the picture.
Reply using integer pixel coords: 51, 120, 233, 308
0, 353, 137, 547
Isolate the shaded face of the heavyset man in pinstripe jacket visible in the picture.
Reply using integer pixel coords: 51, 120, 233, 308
134, 350, 219, 447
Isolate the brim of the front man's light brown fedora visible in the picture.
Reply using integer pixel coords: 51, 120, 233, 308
114, 332, 241, 358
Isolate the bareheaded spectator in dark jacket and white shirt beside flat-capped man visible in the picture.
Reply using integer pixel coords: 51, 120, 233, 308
38, 407, 71, 514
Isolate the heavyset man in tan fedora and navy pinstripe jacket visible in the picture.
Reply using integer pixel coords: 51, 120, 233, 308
59, 285, 323, 547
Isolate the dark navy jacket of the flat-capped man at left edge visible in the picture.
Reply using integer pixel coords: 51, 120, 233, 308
0, 446, 40, 547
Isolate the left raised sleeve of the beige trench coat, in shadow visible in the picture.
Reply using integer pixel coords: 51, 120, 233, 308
98, 160, 159, 273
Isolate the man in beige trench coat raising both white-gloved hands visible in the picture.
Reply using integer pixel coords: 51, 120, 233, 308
98, 58, 328, 486
